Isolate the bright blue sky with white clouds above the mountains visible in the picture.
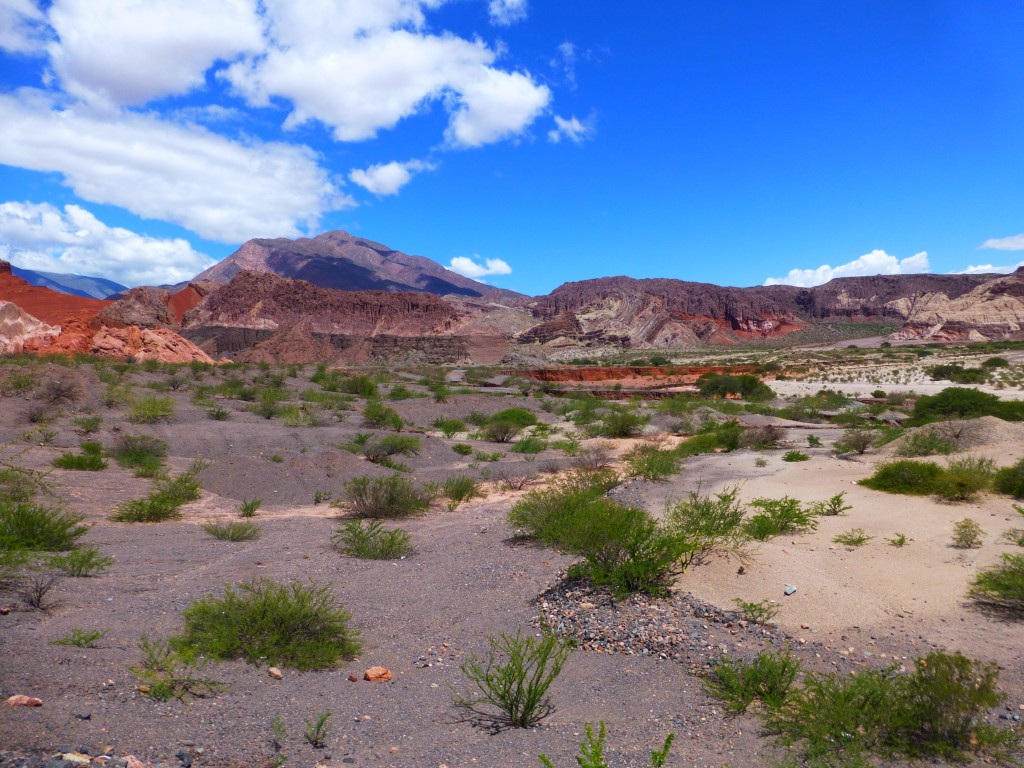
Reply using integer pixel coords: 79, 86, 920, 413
0, 0, 1024, 295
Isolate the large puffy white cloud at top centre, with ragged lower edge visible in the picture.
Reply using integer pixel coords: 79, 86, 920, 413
223, 0, 551, 146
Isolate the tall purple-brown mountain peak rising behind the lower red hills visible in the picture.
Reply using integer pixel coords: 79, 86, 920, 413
194, 230, 523, 300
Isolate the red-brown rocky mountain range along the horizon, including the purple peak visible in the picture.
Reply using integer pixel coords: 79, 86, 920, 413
0, 231, 1024, 364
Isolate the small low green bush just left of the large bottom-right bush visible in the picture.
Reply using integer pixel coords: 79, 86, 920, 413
705, 650, 800, 712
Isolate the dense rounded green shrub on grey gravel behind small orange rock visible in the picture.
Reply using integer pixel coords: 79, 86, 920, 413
172, 579, 361, 670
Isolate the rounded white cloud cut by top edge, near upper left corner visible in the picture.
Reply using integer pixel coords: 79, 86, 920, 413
48, 0, 263, 109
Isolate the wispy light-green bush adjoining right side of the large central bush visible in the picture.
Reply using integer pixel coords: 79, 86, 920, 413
666, 487, 749, 567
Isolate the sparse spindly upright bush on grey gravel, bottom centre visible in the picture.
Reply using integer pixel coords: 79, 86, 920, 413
455, 632, 572, 728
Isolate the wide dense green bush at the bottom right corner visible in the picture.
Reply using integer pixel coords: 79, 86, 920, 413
765, 651, 1015, 761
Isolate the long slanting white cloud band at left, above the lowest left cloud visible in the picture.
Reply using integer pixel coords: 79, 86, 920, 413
0, 93, 352, 243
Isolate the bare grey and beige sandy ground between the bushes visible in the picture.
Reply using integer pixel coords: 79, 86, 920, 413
0, 362, 1024, 768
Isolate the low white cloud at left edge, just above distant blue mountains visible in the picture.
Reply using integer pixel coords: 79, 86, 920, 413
0, 203, 214, 286
